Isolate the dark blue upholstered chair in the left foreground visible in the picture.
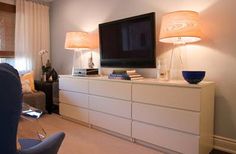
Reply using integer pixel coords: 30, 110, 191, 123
0, 63, 65, 154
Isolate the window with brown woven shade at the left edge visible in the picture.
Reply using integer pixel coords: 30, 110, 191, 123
0, 2, 16, 59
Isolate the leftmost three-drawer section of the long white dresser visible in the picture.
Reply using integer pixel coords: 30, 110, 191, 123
59, 76, 89, 123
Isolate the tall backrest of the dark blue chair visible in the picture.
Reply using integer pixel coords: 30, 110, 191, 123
0, 63, 22, 154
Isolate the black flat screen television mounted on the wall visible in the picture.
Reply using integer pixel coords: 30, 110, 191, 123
99, 13, 156, 68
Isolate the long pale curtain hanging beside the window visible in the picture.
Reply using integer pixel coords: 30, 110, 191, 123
15, 0, 50, 79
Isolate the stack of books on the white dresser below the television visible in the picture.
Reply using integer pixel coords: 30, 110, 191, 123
108, 70, 143, 80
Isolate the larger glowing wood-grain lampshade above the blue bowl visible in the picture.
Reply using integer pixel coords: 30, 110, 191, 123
159, 11, 202, 44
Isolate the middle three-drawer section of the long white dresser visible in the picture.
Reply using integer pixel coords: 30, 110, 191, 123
89, 80, 131, 136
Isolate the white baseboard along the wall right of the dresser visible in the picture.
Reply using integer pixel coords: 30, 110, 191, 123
214, 135, 236, 154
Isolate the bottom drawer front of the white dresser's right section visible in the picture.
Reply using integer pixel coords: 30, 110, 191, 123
132, 122, 199, 154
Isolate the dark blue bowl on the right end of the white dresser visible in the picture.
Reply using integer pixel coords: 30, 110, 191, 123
182, 71, 206, 84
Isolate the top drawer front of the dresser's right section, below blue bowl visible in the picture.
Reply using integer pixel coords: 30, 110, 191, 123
132, 84, 201, 111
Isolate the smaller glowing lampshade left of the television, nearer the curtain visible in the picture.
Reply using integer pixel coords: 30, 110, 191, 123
65, 32, 89, 49
